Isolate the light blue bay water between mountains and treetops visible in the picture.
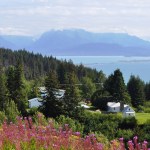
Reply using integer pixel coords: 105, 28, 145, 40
56, 56, 150, 83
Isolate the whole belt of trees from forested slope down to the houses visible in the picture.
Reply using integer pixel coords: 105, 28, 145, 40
0, 48, 150, 116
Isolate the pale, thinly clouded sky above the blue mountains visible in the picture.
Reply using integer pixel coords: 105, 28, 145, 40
0, 0, 150, 39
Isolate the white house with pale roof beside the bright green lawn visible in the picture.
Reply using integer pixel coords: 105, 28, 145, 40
107, 102, 135, 117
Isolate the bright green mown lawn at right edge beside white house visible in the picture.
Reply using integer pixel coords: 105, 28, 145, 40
135, 113, 150, 124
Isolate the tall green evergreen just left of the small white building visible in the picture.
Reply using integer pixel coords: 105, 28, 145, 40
7, 63, 27, 115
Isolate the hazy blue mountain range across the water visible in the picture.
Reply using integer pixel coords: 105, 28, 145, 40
0, 29, 150, 56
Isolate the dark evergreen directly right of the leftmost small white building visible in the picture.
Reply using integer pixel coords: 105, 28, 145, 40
41, 71, 62, 118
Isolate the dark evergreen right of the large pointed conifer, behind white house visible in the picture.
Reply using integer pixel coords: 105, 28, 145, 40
127, 75, 145, 108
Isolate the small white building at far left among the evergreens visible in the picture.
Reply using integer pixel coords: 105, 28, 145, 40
28, 97, 42, 108
